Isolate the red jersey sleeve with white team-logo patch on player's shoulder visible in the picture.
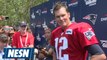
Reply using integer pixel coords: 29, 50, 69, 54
78, 23, 98, 48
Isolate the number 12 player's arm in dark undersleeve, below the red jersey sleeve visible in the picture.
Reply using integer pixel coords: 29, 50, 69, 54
86, 44, 106, 60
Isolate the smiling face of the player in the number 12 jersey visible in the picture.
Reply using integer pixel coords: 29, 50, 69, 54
54, 7, 70, 27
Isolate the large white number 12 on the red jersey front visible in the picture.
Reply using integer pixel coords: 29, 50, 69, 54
55, 37, 69, 60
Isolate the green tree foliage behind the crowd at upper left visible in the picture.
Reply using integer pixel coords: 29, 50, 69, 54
0, 0, 48, 26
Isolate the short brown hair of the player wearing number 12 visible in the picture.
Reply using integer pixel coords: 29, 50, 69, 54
53, 1, 69, 15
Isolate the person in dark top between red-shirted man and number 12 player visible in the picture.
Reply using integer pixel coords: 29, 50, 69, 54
38, 27, 56, 60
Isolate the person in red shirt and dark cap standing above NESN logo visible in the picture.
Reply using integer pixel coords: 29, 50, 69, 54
12, 21, 34, 48
